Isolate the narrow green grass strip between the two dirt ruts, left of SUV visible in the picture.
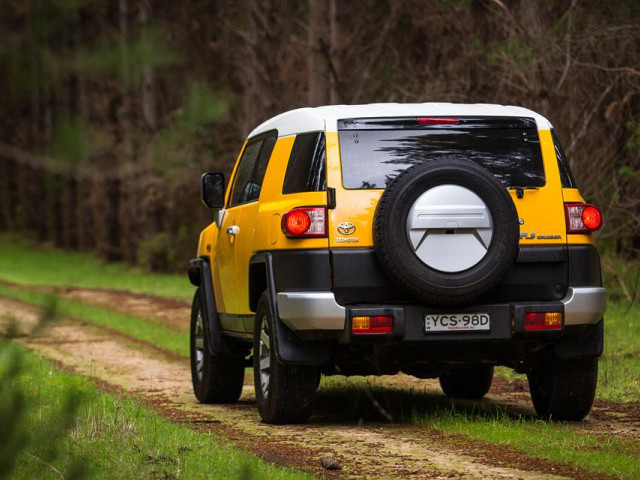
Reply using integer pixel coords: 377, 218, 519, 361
0, 285, 189, 357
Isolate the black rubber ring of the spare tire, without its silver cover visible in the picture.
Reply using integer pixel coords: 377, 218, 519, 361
373, 160, 519, 305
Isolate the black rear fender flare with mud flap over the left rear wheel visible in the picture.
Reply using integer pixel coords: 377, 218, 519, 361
249, 252, 334, 365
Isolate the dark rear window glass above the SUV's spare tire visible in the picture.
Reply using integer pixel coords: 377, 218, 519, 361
339, 118, 545, 189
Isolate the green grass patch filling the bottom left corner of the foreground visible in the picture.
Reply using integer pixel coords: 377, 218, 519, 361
0, 341, 311, 479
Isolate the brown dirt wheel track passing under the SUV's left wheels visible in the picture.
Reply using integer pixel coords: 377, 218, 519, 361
0, 297, 620, 479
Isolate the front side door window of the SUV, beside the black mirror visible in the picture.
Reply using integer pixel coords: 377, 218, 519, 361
229, 133, 277, 207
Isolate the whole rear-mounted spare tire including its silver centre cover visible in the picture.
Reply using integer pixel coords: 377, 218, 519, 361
373, 159, 519, 305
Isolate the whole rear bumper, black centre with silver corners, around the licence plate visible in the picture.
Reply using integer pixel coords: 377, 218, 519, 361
277, 287, 606, 334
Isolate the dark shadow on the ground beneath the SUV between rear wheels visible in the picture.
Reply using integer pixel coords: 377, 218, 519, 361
311, 386, 539, 425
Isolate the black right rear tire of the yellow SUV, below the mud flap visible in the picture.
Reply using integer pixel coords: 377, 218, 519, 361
527, 358, 598, 421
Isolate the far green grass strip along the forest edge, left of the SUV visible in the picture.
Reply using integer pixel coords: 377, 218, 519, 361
0, 233, 194, 300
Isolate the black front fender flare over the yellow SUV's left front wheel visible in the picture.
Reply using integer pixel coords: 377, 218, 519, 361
188, 257, 236, 355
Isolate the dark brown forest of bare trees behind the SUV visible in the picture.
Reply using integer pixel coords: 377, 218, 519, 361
0, 0, 640, 280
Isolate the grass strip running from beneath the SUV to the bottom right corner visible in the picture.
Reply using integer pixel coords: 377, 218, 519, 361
316, 377, 640, 479
